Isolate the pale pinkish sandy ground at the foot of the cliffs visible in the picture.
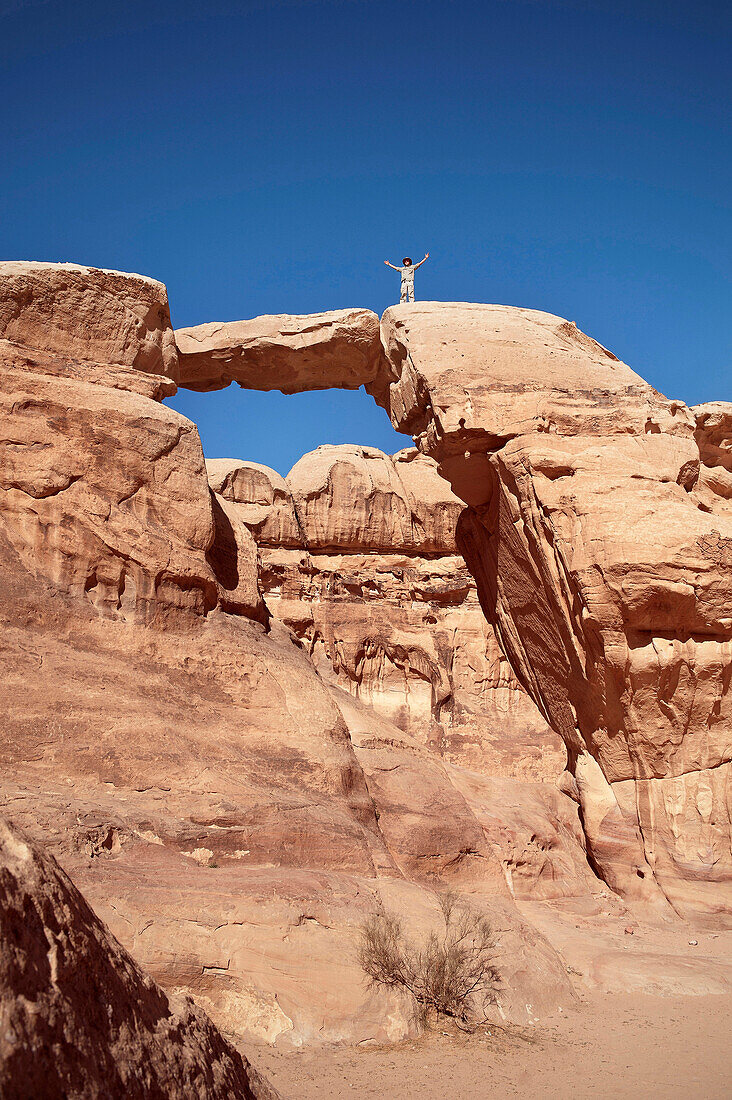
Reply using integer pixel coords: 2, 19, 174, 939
244, 899, 732, 1100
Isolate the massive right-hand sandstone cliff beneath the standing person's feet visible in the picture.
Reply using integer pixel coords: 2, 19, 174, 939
373, 304, 732, 917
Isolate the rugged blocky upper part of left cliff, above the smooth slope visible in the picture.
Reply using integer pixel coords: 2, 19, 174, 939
0, 264, 265, 620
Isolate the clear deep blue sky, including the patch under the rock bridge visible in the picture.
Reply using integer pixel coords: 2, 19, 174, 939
0, 0, 732, 472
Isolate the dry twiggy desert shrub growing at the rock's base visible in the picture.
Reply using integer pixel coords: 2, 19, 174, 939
359, 892, 499, 1029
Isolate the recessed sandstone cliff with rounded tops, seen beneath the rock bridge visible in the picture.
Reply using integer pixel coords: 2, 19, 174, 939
207, 446, 566, 780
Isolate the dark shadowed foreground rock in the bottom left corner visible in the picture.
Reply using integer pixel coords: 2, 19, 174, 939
0, 820, 277, 1100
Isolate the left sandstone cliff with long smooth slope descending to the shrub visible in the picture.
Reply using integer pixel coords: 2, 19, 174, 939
0, 264, 572, 1043
